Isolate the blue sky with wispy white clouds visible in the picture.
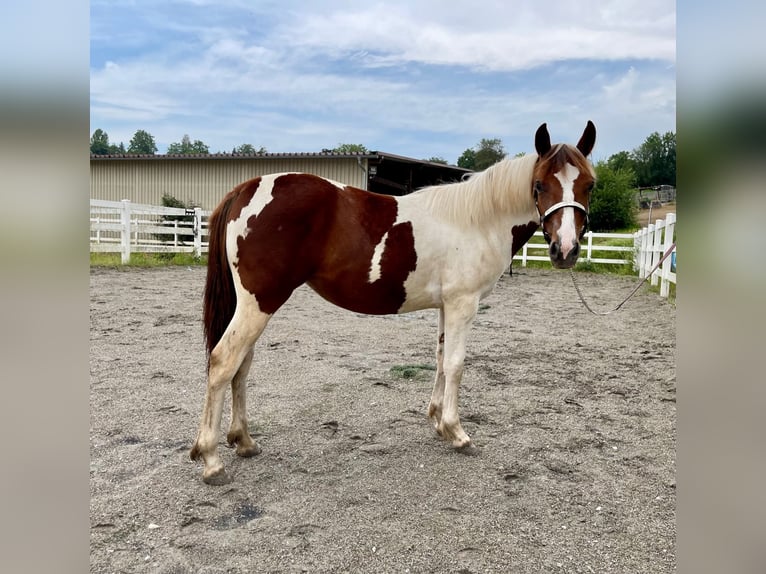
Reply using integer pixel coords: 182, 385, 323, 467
90, 0, 676, 163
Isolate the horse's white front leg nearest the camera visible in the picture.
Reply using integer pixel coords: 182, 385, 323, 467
436, 297, 479, 448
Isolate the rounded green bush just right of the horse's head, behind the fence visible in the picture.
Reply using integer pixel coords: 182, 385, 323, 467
590, 161, 637, 231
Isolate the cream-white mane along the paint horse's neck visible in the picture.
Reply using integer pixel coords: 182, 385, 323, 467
415, 153, 538, 230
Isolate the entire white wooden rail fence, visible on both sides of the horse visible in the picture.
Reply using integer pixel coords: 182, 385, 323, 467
90, 199, 676, 297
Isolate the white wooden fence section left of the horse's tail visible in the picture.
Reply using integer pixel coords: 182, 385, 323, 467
90, 199, 211, 264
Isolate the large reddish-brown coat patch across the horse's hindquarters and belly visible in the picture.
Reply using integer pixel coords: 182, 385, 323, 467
236, 174, 417, 314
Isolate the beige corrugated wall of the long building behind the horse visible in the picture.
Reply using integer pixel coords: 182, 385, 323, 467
90, 157, 367, 209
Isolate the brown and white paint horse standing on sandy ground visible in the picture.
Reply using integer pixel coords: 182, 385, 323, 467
190, 121, 596, 484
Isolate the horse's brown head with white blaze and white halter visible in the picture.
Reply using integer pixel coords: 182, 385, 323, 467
532, 121, 596, 269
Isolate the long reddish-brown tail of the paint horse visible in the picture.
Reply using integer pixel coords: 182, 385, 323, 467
202, 189, 239, 357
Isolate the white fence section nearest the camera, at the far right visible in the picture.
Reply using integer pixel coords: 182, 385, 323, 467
635, 213, 678, 297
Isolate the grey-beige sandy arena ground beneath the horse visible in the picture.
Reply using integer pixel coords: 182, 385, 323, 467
90, 267, 676, 574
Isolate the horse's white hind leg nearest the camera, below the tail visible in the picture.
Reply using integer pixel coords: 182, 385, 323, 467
190, 307, 270, 484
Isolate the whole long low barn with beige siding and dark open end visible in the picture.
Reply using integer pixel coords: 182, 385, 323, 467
90, 151, 470, 210
